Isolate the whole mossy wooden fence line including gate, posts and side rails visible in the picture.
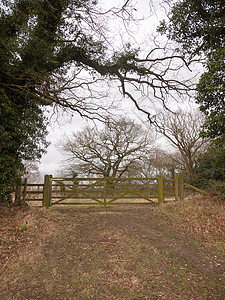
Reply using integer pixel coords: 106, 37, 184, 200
22, 173, 184, 207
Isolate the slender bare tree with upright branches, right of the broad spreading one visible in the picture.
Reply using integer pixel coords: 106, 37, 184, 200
156, 109, 208, 181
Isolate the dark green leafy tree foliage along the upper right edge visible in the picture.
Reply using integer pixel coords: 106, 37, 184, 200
158, 0, 225, 142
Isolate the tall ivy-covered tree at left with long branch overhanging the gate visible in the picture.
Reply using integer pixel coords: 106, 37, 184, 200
0, 0, 194, 202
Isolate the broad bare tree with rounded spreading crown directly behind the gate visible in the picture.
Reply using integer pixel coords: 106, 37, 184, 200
59, 117, 154, 177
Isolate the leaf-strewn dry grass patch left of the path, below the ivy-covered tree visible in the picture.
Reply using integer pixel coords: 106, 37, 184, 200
0, 206, 59, 268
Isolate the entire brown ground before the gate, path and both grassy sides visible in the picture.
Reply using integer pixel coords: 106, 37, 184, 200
0, 196, 225, 299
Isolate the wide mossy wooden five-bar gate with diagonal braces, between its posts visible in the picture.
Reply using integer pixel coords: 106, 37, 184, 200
51, 178, 157, 205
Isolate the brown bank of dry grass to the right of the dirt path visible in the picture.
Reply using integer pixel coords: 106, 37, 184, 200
156, 195, 225, 244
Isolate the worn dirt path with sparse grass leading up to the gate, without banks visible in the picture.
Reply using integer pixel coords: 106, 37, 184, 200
0, 206, 225, 300
